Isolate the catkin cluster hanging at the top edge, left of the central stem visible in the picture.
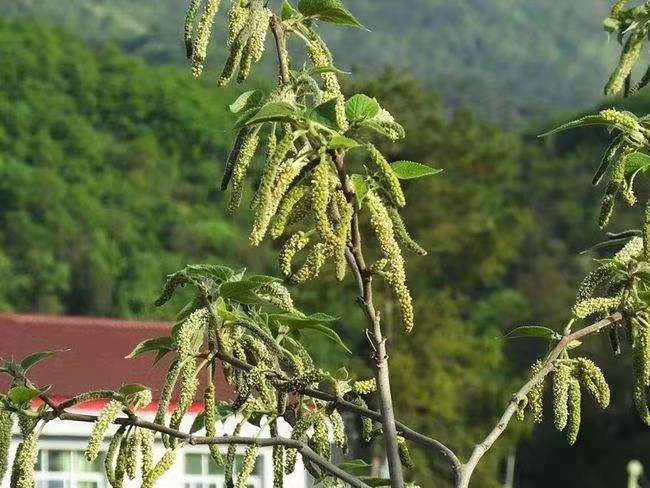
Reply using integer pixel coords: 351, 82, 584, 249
184, 0, 271, 86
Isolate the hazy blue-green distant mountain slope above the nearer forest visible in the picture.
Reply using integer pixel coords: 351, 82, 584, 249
0, 0, 616, 123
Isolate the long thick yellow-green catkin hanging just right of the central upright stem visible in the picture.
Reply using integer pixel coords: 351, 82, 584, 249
366, 190, 414, 333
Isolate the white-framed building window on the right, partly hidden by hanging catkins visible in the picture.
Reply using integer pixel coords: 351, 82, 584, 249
182, 452, 264, 488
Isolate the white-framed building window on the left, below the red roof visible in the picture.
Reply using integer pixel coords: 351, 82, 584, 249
36, 449, 107, 488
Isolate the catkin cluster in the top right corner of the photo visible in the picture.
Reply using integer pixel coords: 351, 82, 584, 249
604, 0, 650, 96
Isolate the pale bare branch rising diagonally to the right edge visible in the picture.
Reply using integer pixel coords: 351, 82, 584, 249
456, 312, 623, 488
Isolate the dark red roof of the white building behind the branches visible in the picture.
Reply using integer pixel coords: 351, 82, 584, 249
0, 314, 232, 399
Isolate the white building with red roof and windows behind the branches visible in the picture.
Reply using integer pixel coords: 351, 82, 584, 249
0, 314, 311, 488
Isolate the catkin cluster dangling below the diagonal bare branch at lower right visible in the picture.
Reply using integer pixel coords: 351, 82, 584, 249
516, 358, 610, 445
